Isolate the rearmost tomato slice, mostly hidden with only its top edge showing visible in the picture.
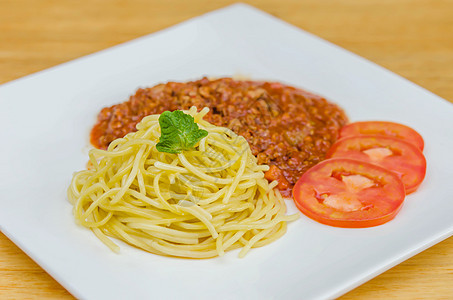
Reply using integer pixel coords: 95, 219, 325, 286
340, 121, 425, 151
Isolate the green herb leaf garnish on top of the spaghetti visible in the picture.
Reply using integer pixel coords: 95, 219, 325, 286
156, 110, 208, 153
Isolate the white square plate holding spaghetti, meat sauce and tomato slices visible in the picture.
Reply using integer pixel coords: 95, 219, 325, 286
0, 4, 453, 299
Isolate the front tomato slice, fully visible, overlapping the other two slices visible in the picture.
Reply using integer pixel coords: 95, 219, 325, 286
293, 158, 405, 228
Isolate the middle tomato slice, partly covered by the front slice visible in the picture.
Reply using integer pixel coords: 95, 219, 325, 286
326, 135, 426, 194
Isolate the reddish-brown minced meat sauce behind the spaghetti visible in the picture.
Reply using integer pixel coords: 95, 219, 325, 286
91, 78, 347, 197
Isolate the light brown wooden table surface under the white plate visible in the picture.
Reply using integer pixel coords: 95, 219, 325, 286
0, 0, 453, 299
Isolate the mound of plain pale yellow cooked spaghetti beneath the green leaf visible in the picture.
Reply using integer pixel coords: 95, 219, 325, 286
68, 107, 297, 258
